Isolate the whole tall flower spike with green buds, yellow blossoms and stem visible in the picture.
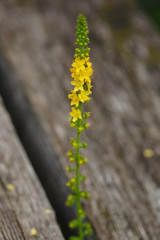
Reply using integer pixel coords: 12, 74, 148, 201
66, 14, 93, 240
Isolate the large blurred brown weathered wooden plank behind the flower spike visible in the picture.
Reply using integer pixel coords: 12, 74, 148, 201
0, 0, 160, 240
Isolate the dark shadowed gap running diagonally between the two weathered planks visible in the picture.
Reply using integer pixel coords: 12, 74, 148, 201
0, 55, 76, 238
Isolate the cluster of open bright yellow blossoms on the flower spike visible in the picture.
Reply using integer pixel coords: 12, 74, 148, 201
68, 57, 93, 122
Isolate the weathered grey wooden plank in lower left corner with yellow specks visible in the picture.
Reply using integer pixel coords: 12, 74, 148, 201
0, 98, 64, 240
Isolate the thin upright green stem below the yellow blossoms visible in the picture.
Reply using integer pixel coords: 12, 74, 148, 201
76, 103, 84, 240
